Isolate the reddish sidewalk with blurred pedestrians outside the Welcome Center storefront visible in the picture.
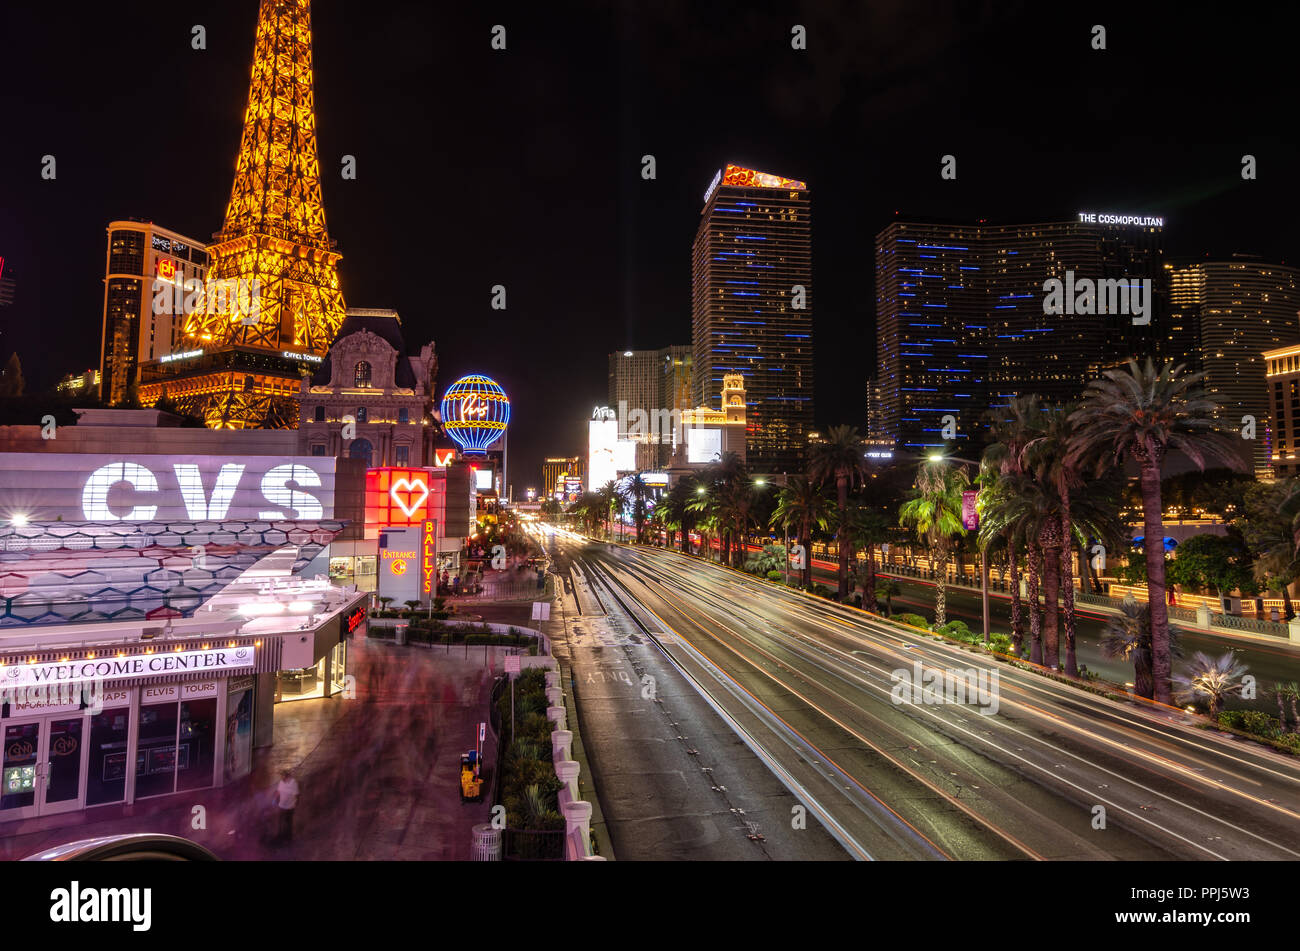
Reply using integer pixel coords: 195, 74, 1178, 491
0, 638, 497, 861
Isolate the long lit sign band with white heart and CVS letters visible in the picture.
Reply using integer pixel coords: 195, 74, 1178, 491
0, 452, 335, 522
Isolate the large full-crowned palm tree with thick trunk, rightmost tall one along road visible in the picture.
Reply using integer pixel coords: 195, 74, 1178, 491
1069, 359, 1244, 703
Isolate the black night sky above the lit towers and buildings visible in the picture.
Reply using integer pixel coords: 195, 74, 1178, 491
0, 0, 1300, 495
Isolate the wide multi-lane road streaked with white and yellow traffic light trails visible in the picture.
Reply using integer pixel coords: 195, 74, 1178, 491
535, 534, 1300, 860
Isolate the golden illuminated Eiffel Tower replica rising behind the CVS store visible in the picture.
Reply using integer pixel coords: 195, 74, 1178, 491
139, 0, 346, 429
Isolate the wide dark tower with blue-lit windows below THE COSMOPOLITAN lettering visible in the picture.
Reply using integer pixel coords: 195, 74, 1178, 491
876, 216, 1182, 452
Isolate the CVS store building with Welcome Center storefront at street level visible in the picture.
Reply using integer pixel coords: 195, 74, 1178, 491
0, 433, 368, 824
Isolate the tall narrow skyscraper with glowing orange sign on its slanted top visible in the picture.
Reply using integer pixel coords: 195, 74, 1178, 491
692, 165, 813, 472
